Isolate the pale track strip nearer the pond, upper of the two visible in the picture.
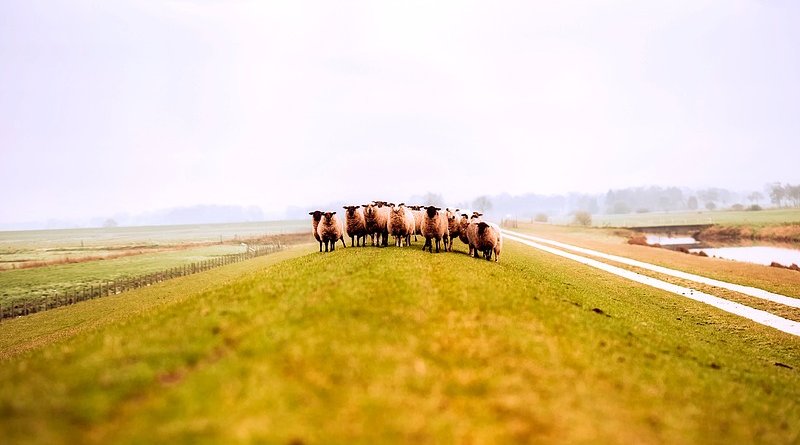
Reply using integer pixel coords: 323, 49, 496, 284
502, 230, 800, 308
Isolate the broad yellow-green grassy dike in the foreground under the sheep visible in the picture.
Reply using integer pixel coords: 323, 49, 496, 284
0, 242, 800, 444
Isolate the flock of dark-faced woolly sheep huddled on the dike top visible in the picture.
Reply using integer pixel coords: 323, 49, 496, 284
309, 201, 503, 261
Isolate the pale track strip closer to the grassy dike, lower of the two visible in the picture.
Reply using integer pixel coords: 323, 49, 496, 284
502, 230, 800, 336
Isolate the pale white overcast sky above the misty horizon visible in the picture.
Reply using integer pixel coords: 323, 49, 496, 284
0, 0, 800, 223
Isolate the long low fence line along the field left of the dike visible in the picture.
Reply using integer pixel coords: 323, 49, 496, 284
0, 242, 286, 320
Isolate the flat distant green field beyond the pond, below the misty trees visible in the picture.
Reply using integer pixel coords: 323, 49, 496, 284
592, 208, 800, 227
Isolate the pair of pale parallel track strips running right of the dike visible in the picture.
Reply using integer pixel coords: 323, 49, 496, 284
502, 230, 800, 336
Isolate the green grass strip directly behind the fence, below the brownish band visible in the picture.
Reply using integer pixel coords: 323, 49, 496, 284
0, 245, 250, 305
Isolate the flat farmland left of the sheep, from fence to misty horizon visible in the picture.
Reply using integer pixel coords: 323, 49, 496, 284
0, 221, 310, 305
